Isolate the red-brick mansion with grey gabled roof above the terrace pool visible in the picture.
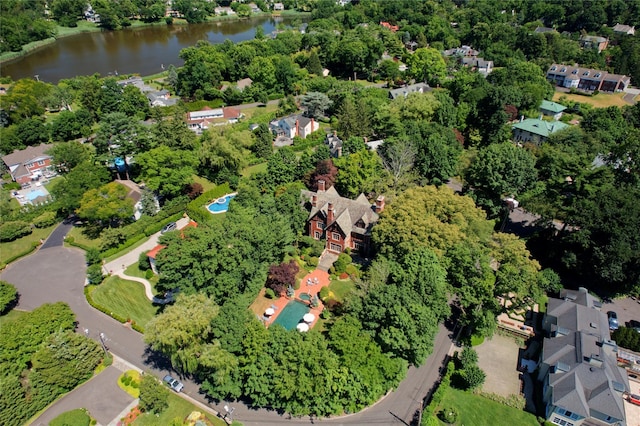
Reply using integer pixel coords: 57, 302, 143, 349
302, 180, 384, 256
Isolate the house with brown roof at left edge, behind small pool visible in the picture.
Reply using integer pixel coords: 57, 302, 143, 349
2, 144, 55, 185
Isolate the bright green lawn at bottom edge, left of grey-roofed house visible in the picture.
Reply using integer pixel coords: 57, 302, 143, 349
440, 388, 540, 426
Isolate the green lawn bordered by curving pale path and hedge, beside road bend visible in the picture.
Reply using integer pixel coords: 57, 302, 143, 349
91, 276, 158, 328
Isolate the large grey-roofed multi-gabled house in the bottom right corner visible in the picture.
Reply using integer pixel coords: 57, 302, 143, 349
538, 288, 629, 426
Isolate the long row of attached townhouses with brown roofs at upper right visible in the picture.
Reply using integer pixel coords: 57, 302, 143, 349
547, 64, 631, 92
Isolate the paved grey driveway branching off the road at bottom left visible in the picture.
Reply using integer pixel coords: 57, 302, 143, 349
33, 366, 134, 426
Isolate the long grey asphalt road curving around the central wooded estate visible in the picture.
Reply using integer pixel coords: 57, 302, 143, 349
0, 224, 452, 426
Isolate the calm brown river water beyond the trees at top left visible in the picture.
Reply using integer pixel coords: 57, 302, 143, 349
0, 16, 300, 83
